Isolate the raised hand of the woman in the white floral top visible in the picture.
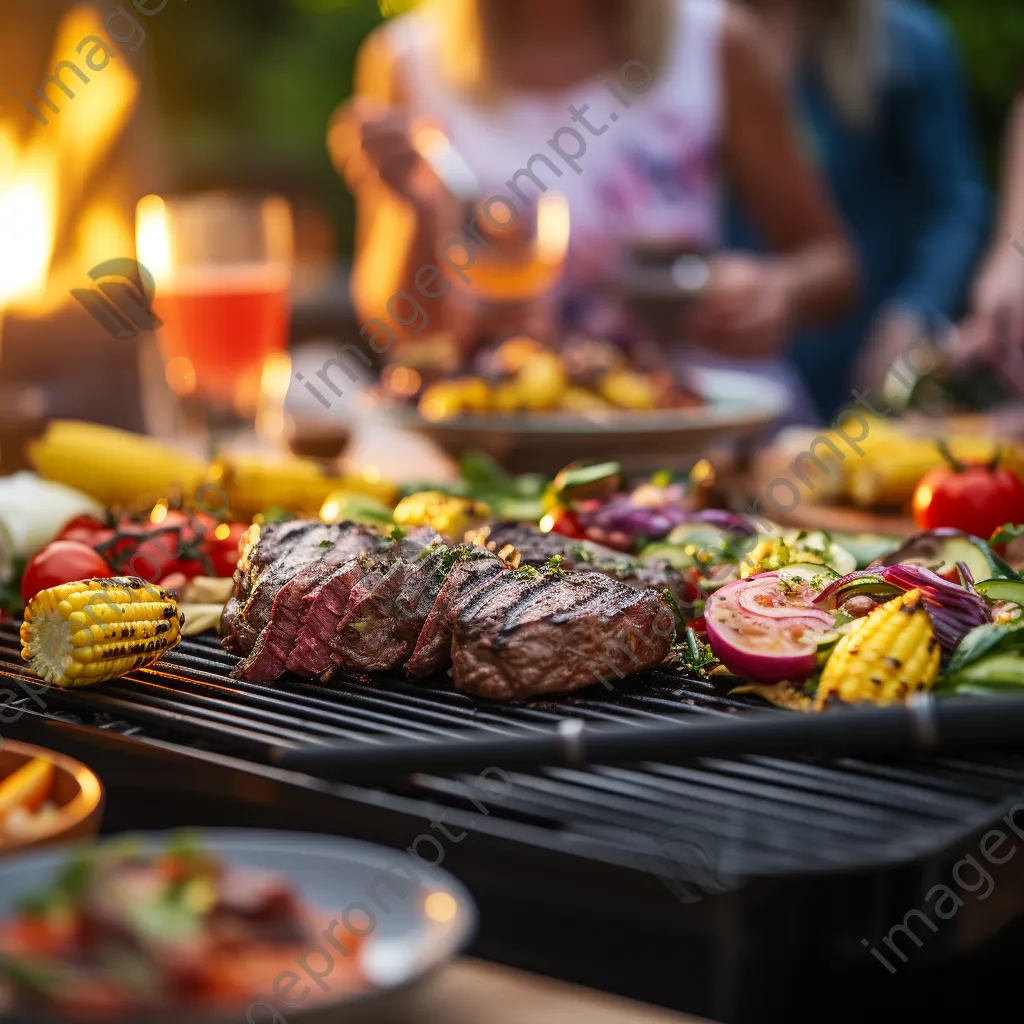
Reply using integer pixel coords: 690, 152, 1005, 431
328, 98, 440, 208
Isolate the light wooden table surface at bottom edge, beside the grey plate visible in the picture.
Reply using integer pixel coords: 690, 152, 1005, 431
360, 958, 708, 1024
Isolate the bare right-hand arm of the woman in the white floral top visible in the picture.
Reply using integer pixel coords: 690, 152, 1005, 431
724, 1, 857, 327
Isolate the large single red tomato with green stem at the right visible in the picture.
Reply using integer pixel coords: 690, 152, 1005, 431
913, 455, 1024, 539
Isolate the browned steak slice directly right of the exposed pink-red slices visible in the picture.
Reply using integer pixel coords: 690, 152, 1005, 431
331, 545, 458, 672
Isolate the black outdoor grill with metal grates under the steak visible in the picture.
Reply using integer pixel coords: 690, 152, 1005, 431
0, 624, 1024, 1021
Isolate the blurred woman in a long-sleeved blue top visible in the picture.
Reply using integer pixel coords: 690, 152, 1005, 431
728, 0, 988, 420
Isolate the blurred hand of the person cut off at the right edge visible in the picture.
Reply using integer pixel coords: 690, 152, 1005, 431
953, 244, 1024, 393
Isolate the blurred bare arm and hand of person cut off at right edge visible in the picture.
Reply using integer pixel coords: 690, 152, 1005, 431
956, 92, 1024, 394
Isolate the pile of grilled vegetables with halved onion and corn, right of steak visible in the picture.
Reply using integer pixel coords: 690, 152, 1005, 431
705, 524, 1024, 711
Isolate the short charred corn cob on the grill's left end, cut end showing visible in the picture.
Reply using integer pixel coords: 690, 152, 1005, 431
22, 577, 183, 687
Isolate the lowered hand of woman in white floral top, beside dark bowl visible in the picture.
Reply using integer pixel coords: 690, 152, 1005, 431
688, 254, 793, 358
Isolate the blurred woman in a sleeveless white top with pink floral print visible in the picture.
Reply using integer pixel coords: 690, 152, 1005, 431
329, 0, 856, 400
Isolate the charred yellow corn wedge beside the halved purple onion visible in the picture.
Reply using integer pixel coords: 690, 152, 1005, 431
814, 590, 942, 711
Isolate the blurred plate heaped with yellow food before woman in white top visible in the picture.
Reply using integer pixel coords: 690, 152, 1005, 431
379, 337, 785, 474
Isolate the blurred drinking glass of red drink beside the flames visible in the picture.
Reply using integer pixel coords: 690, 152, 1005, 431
136, 193, 293, 443
